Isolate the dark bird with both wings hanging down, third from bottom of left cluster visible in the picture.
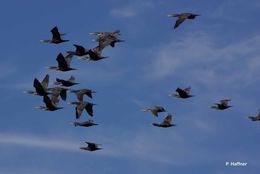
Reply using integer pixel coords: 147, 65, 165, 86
68, 101, 96, 119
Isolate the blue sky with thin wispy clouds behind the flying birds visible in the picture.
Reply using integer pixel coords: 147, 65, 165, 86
0, 0, 260, 174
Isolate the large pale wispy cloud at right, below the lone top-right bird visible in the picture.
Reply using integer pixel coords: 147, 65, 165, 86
147, 34, 260, 86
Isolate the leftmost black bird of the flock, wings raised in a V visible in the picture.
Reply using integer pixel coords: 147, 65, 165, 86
25, 74, 49, 96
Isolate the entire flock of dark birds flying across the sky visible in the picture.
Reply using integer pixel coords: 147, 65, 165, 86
26, 13, 260, 151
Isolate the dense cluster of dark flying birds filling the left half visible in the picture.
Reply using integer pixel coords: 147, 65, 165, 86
26, 26, 124, 151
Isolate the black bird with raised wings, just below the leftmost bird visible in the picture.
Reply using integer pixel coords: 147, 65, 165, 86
35, 94, 62, 111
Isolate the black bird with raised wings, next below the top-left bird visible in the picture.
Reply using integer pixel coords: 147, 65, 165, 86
48, 53, 76, 71
